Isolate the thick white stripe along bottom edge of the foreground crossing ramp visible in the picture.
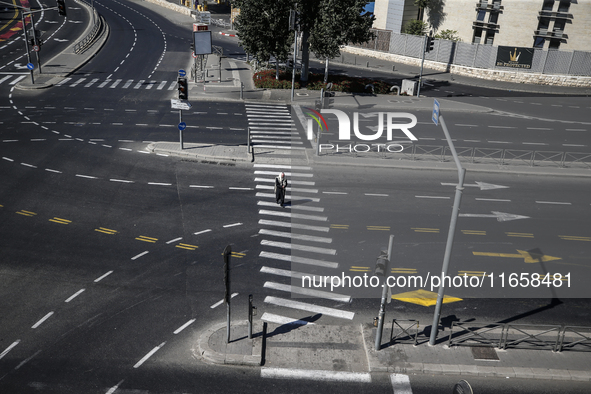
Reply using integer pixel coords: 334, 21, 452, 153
261, 367, 371, 383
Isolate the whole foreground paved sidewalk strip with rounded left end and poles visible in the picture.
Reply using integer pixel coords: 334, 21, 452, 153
194, 321, 591, 382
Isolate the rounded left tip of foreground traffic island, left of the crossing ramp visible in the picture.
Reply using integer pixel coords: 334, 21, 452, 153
193, 321, 264, 366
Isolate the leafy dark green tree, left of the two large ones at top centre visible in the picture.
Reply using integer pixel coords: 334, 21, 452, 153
233, 0, 293, 77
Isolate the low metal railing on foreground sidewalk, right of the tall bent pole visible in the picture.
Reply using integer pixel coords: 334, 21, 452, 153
447, 322, 591, 352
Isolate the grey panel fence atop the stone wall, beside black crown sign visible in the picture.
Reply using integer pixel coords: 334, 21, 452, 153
353, 29, 591, 76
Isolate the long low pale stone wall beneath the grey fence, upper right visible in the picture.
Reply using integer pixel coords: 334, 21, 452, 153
341, 46, 591, 87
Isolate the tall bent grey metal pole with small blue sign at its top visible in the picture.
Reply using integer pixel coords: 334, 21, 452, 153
429, 100, 466, 346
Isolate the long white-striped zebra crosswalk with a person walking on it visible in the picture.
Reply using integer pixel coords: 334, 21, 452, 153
245, 103, 355, 325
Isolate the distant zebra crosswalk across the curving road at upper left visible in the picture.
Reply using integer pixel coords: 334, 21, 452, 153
0, 74, 177, 90
